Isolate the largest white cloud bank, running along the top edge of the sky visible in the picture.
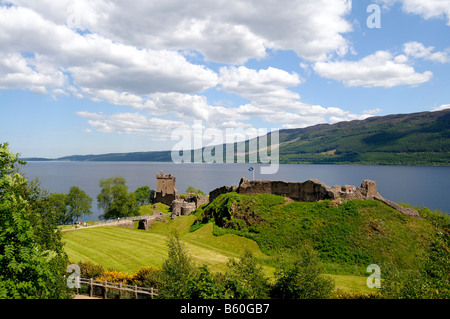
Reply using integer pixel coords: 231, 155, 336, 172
6, 0, 351, 64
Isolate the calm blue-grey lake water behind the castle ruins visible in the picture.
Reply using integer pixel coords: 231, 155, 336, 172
21, 162, 450, 219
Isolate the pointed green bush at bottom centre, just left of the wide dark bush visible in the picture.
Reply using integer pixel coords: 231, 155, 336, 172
225, 250, 270, 299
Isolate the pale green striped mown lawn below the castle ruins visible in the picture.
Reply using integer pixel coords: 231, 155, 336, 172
63, 215, 371, 292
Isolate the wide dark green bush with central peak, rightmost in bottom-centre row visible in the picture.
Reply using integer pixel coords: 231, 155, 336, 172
272, 245, 334, 299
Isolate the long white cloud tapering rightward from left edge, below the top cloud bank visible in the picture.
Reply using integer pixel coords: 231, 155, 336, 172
0, 7, 217, 95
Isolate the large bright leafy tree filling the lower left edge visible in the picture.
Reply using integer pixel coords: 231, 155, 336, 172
0, 143, 70, 299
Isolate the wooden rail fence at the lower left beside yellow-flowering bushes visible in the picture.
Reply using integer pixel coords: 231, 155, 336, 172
77, 278, 158, 299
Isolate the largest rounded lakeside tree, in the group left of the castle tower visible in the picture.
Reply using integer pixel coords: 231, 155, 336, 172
97, 177, 138, 219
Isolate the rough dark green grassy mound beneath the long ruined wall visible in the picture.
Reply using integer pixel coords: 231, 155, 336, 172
191, 193, 450, 294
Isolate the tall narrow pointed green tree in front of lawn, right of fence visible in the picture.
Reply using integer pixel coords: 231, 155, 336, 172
159, 233, 195, 299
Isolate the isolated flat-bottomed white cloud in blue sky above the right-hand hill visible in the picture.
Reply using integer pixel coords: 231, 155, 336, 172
314, 51, 433, 88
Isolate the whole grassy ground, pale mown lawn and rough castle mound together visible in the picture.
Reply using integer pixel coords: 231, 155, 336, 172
63, 193, 450, 298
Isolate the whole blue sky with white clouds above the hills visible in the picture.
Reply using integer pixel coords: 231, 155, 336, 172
0, 0, 450, 158
